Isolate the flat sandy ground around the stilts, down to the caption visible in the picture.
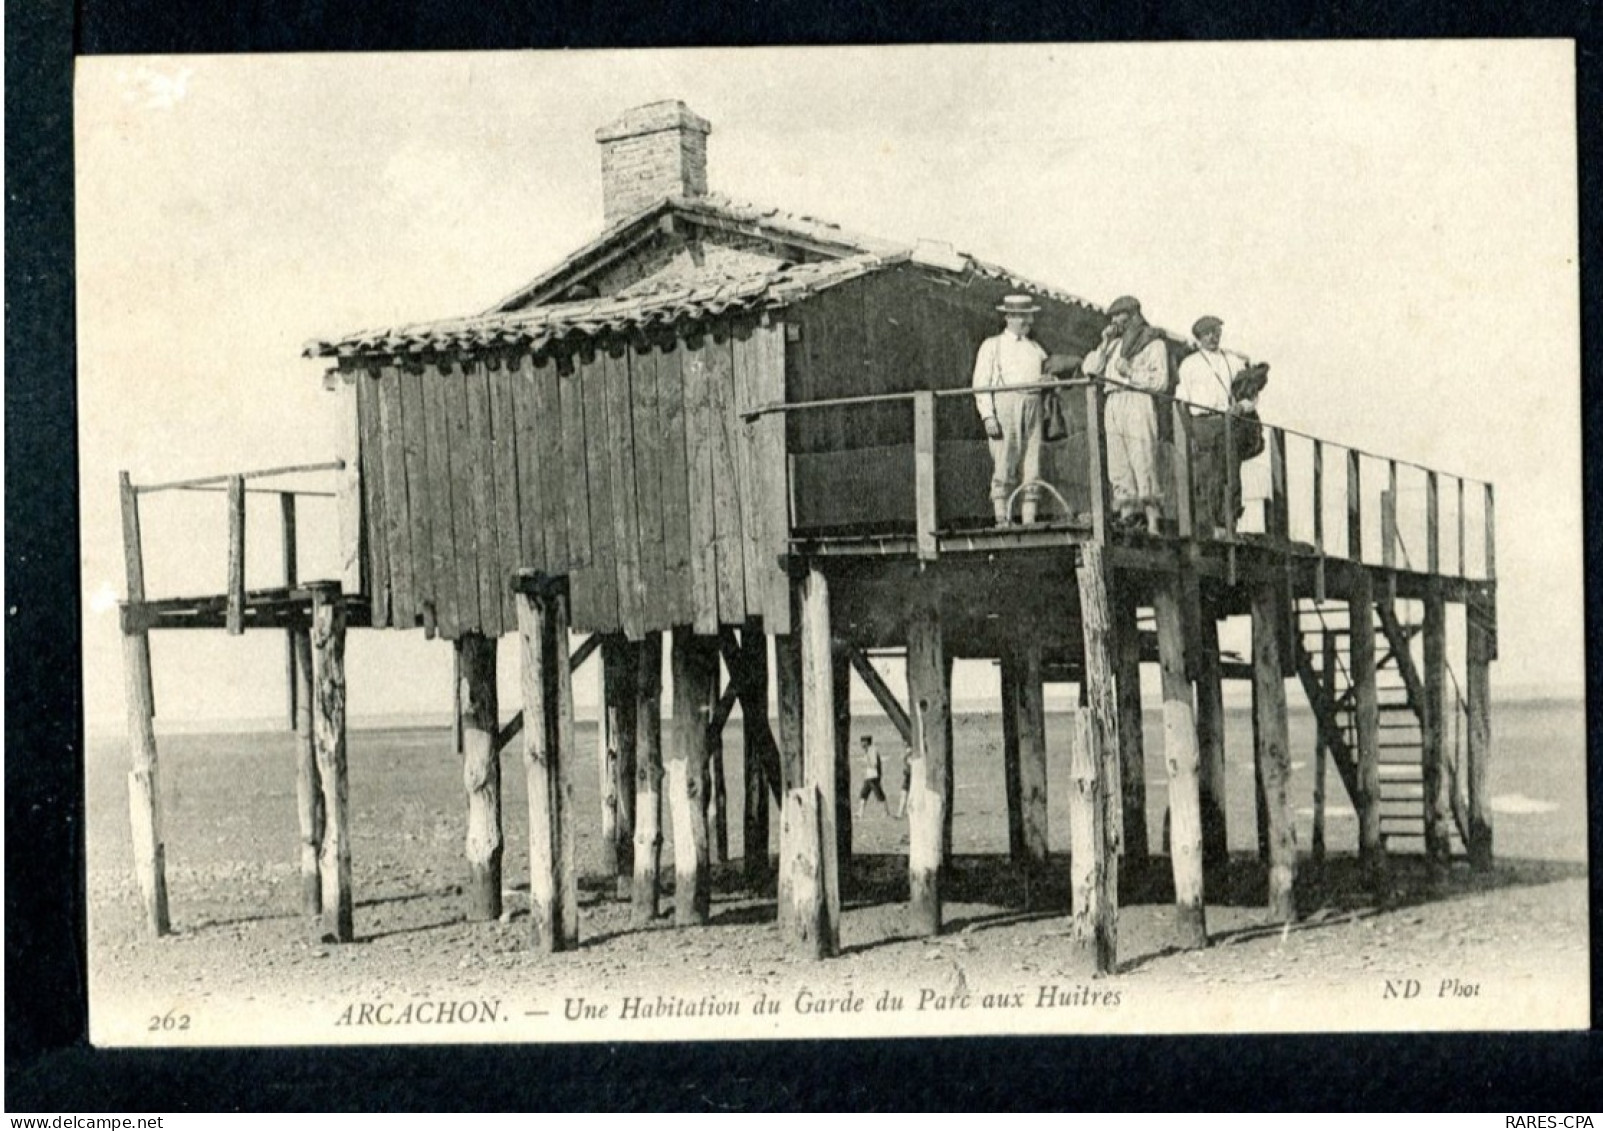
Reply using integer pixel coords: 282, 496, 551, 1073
87, 703, 1589, 1044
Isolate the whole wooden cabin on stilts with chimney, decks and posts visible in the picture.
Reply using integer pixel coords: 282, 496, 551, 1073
125, 103, 1496, 969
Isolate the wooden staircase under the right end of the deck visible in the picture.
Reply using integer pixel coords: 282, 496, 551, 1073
1295, 601, 1462, 852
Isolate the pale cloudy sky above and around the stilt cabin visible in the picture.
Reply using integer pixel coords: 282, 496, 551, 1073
75, 40, 1584, 731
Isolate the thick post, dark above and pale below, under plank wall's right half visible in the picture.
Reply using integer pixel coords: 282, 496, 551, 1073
667, 628, 718, 928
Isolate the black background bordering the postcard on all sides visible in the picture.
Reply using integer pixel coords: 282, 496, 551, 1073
5, 0, 1603, 1113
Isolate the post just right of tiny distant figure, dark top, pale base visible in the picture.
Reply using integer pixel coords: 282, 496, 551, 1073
907, 591, 952, 936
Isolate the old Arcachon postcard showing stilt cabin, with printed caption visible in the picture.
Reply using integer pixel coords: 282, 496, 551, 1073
74, 40, 1590, 1046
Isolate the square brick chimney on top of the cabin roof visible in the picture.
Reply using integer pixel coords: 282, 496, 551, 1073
596, 99, 712, 227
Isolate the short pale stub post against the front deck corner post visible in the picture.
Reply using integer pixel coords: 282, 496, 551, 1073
1069, 710, 1122, 974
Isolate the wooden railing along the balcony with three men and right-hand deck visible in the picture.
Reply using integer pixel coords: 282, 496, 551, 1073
744, 376, 1496, 580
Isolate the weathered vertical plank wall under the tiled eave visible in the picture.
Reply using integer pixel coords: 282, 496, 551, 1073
356, 322, 790, 639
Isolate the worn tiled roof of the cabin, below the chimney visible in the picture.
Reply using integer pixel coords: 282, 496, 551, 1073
305, 195, 1101, 357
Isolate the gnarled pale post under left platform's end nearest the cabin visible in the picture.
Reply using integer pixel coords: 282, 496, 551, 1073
311, 585, 356, 942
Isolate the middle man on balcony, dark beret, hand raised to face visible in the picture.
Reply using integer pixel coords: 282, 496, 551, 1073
1080, 295, 1169, 533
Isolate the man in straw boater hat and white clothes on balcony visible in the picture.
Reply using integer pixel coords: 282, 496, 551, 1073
975, 295, 1047, 525
